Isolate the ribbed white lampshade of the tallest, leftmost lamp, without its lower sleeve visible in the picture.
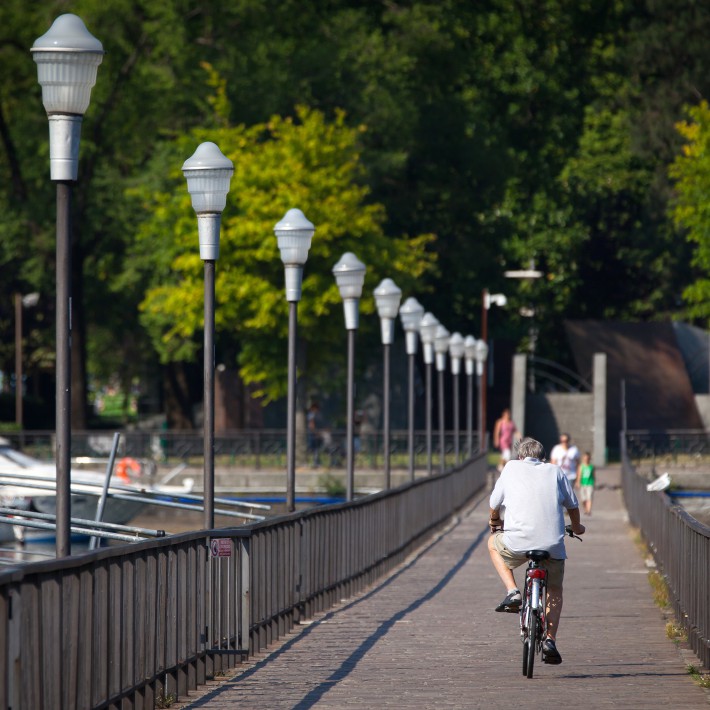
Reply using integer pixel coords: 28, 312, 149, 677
30, 14, 104, 116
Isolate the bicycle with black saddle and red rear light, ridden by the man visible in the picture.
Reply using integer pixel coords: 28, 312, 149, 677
520, 525, 582, 678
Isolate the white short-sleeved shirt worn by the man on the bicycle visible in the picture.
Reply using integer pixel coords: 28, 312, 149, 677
490, 458, 579, 560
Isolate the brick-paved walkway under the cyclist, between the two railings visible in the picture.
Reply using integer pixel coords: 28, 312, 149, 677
177, 468, 710, 710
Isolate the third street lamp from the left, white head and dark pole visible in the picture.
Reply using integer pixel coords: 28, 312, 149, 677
274, 209, 315, 512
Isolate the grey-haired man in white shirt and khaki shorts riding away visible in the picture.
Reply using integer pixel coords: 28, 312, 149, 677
488, 437, 585, 664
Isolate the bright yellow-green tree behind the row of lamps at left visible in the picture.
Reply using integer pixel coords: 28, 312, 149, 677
129, 107, 434, 408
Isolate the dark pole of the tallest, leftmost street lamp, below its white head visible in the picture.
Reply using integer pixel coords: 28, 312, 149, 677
55, 181, 72, 557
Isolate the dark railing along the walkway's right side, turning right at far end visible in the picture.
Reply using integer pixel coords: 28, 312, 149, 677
621, 432, 710, 668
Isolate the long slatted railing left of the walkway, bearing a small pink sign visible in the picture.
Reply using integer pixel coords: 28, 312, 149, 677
0, 456, 487, 710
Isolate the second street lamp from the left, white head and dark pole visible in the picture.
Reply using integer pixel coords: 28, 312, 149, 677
182, 141, 234, 530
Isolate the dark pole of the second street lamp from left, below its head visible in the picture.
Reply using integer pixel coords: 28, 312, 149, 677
204, 259, 215, 530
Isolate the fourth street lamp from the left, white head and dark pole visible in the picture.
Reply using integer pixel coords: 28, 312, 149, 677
333, 252, 366, 501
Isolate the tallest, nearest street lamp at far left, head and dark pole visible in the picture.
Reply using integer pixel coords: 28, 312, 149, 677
31, 14, 104, 557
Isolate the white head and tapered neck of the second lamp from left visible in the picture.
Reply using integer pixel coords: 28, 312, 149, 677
182, 141, 234, 261
